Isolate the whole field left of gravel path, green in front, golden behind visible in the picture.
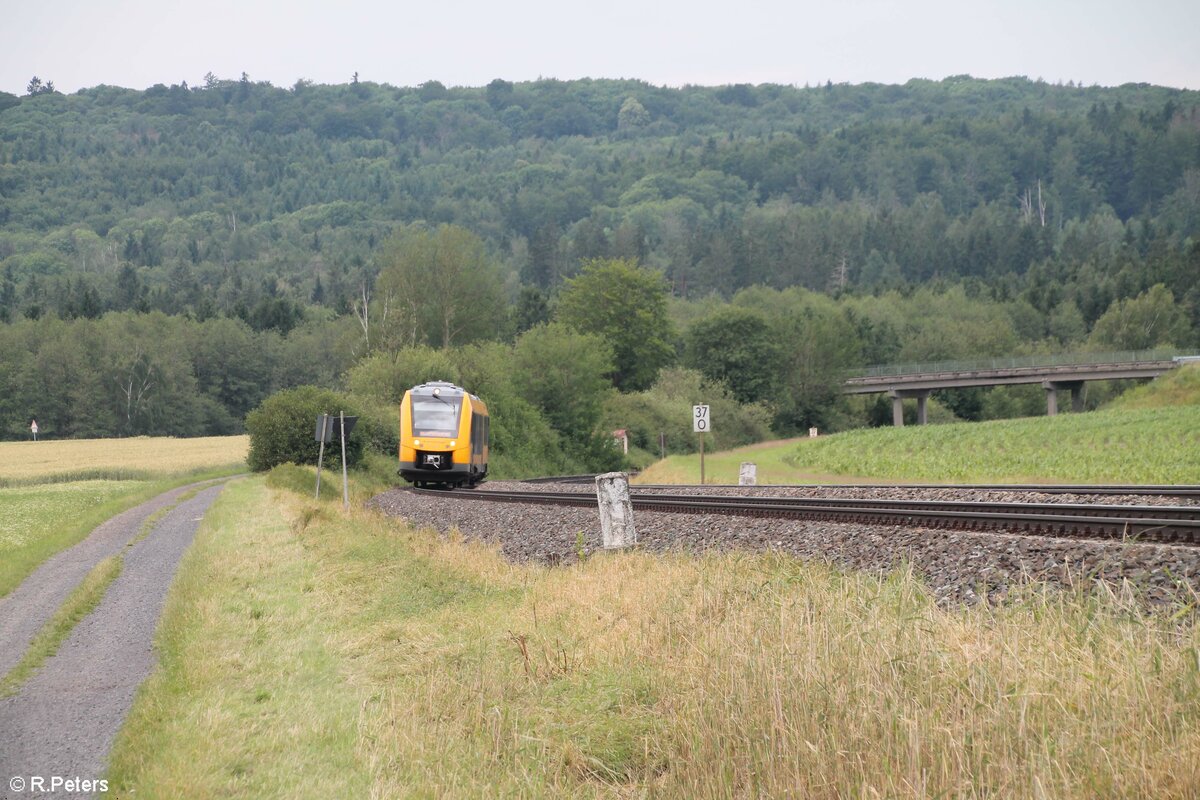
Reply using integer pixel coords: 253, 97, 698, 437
0, 437, 248, 597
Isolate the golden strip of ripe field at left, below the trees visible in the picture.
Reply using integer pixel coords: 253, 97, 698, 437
0, 435, 250, 486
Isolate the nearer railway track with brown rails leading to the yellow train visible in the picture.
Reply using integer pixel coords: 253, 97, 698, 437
410, 484, 1200, 546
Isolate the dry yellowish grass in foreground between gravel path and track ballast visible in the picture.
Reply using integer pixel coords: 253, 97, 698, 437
109, 470, 1200, 798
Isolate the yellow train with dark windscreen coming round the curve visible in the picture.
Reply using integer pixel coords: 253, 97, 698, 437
400, 380, 491, 488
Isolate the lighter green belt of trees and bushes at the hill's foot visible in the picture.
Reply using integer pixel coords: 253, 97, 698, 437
0, 225, 1196, 471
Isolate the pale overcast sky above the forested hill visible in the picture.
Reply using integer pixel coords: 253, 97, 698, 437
0, 0, 1200, 95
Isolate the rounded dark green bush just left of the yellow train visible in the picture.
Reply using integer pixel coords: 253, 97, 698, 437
246, 386, 374, 473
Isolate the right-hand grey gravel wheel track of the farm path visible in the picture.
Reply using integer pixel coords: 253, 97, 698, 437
0, 486, 222, 800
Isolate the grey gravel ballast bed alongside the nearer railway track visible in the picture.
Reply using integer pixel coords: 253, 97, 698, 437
368, 482, 1200, 603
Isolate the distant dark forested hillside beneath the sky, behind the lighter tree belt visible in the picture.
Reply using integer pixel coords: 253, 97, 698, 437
0, 76, 1200, 327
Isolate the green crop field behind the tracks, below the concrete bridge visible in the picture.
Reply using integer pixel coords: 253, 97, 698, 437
637, 404, 1200, 483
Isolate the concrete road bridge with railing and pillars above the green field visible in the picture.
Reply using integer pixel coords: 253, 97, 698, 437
842, 350, 1200, 426
